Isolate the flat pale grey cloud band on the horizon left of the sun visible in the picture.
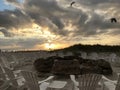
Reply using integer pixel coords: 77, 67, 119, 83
0, 38, 45, 50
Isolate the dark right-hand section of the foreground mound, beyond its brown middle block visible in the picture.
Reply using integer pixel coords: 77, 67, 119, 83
79, 59, 113, 75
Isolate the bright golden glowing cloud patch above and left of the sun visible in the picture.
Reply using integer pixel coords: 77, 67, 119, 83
11, 23, 56, 39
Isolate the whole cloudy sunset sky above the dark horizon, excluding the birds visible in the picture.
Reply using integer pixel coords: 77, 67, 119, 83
0, 0, 120, 50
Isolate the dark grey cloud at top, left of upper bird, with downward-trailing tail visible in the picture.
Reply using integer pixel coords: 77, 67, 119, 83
24, 0, 65, 29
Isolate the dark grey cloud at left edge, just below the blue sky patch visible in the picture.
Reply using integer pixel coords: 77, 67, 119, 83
0, 9, 31, 28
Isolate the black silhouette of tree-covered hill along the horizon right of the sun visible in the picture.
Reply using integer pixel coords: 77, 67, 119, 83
54, 44, 120, 52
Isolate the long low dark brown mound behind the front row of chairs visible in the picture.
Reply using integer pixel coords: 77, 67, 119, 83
34, 56, 112, 75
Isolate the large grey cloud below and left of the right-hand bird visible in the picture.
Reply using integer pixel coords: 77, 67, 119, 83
74, 13, 120, 37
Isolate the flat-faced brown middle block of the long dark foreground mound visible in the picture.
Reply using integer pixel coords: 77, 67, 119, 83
51, 60, 81, 75
